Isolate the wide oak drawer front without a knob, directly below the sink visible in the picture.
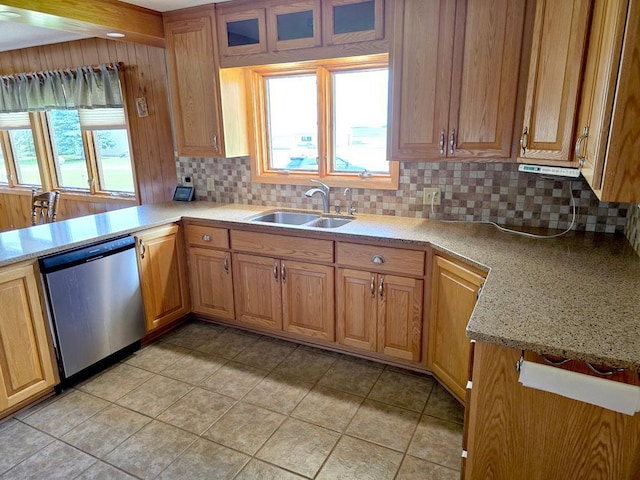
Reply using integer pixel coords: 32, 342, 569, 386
231, 230, 333, 263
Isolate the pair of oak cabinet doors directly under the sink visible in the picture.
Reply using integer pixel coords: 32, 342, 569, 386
233, 253, 335, 341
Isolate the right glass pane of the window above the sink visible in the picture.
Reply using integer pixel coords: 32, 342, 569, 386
332, 68, 389, 174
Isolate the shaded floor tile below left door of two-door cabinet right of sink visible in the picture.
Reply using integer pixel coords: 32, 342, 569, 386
318, 358, 384, 397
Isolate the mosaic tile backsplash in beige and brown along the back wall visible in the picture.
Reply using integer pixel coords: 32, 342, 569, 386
177, 157, 638, 233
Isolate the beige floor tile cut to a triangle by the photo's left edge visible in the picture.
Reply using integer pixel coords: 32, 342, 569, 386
0, 419, 54, 475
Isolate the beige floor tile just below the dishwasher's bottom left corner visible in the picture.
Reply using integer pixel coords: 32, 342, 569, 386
23, 390, 110, 437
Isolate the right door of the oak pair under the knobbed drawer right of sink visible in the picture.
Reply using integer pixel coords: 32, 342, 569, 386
377, 275, 423, 362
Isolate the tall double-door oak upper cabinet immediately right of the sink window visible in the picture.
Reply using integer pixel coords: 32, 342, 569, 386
389, 0, 525, 160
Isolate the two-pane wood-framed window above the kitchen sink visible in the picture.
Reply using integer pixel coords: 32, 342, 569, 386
252, 55, 398, 189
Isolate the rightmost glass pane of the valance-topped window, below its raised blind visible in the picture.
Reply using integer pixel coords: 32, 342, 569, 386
93, 129, 135, 193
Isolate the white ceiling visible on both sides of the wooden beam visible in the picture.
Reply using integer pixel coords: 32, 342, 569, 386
0, 0, 229, 52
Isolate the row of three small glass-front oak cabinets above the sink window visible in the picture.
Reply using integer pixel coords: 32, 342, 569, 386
216, 0, 390, 67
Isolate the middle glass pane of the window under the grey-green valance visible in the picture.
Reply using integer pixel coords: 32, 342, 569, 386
48, 110, 89, 190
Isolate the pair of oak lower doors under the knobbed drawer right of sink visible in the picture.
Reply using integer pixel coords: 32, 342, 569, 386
336, 268, 424, 362
